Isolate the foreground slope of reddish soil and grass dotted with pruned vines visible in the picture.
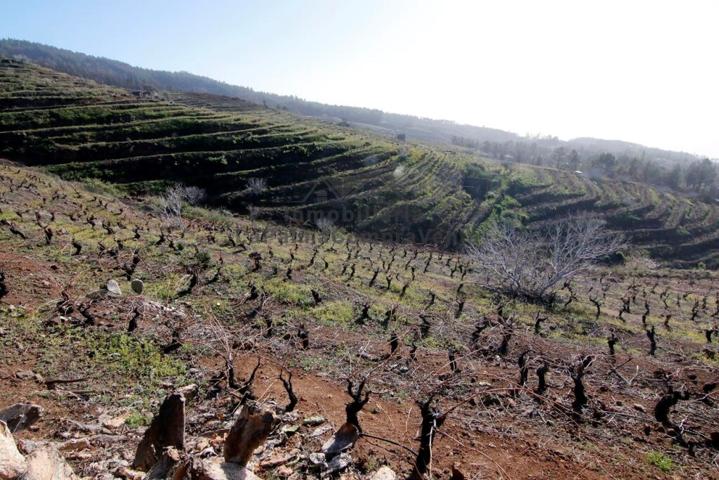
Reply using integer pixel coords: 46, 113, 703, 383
0, 162, 719, 480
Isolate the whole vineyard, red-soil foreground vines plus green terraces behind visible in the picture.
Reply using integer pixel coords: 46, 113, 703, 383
0, 60, 719, 480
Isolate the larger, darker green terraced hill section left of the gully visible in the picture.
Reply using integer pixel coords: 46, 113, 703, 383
0, 61, 478, 249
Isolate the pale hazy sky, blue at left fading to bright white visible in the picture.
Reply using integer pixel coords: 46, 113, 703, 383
0, 0, 719, 158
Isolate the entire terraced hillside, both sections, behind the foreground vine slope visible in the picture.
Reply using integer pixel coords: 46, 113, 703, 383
0, 60, 719, 267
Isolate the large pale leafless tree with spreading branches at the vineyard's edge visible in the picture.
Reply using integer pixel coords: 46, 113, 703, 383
468, 217, 623, 303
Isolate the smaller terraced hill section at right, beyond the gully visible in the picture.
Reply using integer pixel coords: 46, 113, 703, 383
478, 166, 719, 268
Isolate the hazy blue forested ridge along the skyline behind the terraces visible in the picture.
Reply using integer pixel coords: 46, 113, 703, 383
0, 39, 699, 163
